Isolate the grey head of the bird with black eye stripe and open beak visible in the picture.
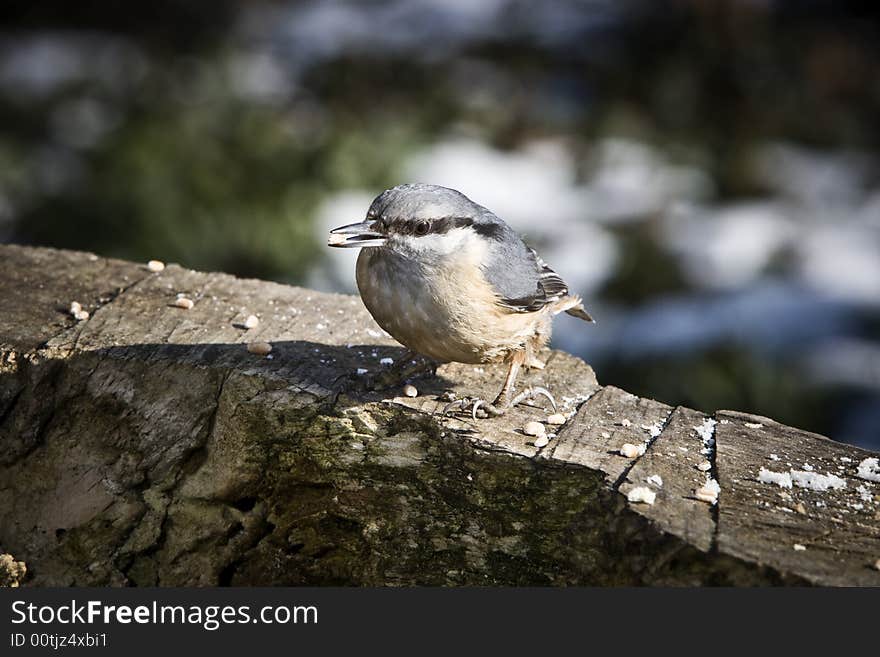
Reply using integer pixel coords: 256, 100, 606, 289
328, 183, 512, 256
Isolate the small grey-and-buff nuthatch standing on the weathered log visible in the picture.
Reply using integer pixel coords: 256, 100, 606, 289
327, 183, 594, 420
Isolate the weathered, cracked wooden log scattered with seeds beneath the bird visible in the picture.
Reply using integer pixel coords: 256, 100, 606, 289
0, 246, 880, 585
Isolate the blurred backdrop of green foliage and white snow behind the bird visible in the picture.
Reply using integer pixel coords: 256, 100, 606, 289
0, 0, 880, 448
